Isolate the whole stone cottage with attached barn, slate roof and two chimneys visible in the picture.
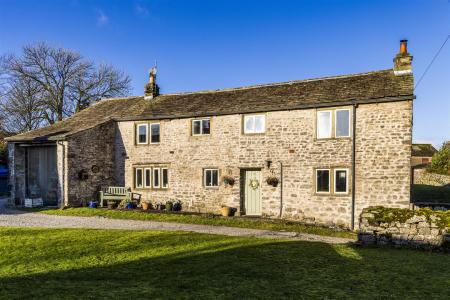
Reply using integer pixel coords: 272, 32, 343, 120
8, 41, 414, 228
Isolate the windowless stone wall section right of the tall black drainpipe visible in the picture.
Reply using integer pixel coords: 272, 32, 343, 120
355, 101, 412, 219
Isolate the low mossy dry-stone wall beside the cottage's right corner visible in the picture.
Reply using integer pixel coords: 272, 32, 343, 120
358, 207, 450, 250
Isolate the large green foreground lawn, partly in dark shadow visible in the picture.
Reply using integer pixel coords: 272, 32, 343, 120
0, 228, 450, 300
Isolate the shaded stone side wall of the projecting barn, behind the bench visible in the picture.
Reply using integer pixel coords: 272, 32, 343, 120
66, 121, 116, 206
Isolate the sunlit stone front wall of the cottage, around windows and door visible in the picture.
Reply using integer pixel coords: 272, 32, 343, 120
115, 101, 412, 227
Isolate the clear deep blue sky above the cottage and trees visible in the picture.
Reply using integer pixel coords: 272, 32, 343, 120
0, 0, 450, 146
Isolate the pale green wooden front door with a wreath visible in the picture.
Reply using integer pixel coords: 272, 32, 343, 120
244, 170, 261, 216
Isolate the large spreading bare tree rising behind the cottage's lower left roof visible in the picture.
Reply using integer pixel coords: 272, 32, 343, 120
4, 43, 131, 124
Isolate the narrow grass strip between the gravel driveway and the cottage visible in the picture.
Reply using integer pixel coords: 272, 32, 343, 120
29, 208, 356, 239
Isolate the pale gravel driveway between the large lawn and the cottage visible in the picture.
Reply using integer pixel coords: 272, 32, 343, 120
0, 199, 353, 244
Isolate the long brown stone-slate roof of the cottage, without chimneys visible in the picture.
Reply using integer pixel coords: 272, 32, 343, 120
8, 69, 413, 141
